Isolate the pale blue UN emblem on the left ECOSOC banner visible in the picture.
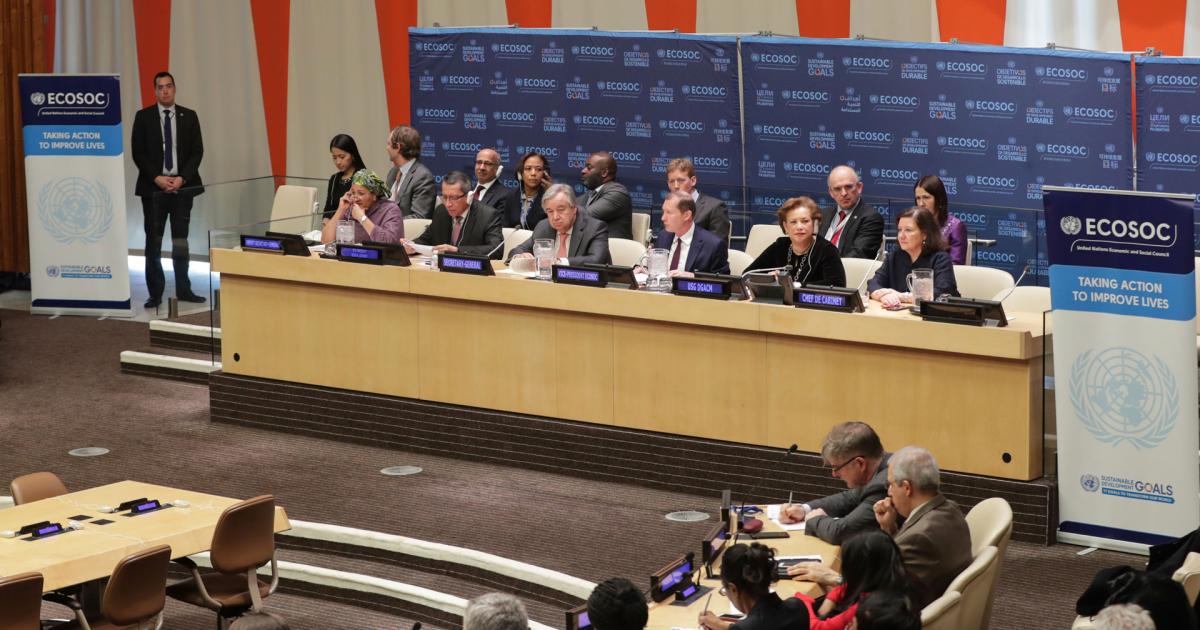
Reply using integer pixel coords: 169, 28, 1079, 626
37, 178, 113, 245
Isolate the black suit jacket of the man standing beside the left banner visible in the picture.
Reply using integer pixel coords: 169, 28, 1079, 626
130, 103, 204, 197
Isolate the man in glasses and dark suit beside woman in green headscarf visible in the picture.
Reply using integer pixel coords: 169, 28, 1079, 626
404, 170, 504, 259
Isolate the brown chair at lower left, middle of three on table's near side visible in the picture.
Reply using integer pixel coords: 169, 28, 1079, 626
46, 545, 170, 630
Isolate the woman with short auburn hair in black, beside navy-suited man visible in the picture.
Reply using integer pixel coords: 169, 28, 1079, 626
746, 197, 846, 287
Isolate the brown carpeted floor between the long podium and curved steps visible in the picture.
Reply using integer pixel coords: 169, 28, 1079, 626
0, 311, 1142, 629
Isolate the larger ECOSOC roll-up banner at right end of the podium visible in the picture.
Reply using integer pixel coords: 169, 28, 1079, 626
1044, 187, 1200, 550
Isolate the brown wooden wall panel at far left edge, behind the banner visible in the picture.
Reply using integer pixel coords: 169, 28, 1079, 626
0, 0, 50, 271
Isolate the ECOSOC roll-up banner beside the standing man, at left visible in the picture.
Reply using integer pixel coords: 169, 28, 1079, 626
19, 74, 132, 317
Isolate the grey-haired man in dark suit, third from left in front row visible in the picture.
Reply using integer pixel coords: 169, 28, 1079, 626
509, 184, 612, 265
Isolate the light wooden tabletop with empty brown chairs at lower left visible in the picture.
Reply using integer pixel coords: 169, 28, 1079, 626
0, 481, 292, 593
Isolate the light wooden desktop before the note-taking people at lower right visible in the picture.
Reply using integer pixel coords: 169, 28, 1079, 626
641, 514, 840, 630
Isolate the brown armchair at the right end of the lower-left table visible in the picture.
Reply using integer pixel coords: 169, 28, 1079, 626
167, 494, 280, 628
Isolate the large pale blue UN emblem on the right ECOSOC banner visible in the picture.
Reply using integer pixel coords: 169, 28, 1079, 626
1070, 348, 1180, 449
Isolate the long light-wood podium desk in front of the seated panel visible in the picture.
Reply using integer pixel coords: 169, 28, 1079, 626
211, 248, 1045, 480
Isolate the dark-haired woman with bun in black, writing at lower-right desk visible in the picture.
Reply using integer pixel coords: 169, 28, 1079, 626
700, 542, 809, 630
